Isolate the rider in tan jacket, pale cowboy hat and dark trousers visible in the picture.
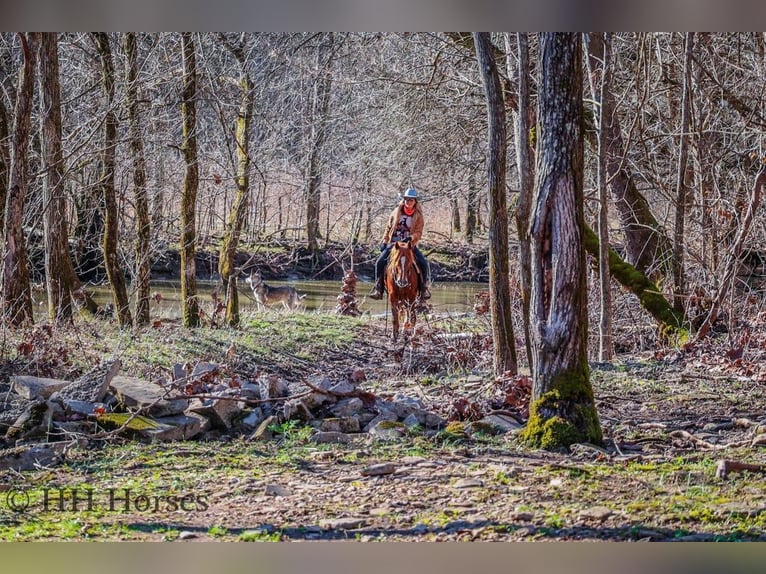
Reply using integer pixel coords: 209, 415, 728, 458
370, 187, 431, 300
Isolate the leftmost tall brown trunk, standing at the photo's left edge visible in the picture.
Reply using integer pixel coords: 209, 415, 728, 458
0, 33, 39, 325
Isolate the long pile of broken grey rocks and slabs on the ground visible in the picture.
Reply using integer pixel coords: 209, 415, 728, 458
0, 360, 524, 468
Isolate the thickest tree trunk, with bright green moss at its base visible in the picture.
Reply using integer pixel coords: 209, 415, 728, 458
521, 33, 602, 449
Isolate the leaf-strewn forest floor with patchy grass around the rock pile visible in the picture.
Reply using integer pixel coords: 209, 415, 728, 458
0, 294, 766, 541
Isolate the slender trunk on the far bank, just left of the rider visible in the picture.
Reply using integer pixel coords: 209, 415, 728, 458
306, 32, 334, 251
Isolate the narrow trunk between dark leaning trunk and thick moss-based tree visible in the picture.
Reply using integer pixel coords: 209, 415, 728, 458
506, 33, 535, 365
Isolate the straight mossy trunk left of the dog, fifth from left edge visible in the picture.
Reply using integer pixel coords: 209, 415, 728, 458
181, 32, 200, 327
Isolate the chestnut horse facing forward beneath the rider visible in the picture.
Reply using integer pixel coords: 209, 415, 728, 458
386, 241, 419, 341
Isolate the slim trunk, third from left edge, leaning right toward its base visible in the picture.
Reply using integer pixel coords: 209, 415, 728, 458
93, 32, 133, 327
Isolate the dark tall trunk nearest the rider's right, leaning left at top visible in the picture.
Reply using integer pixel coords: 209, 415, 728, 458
474, 32, 518, 376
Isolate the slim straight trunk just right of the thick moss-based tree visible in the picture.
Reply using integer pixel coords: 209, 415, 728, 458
588, 32, 614, 361
